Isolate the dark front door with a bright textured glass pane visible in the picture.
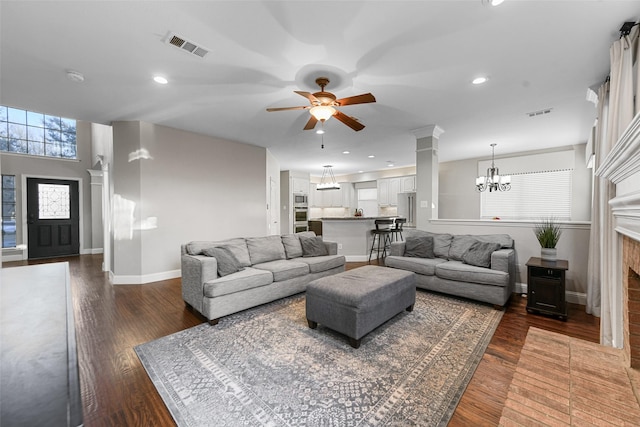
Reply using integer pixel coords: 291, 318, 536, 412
27, 178, 80, 259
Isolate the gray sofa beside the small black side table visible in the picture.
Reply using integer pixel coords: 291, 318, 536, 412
385, 230, 516, 306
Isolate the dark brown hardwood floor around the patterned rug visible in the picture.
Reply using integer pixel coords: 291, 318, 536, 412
3, 255, 599, 427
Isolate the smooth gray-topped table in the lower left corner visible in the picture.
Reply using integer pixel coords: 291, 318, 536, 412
0, 262, 82, 427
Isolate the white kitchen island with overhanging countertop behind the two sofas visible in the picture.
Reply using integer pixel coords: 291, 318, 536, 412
314, 216, 395, 262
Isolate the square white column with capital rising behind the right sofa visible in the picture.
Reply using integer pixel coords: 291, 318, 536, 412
413, 125, 444, 230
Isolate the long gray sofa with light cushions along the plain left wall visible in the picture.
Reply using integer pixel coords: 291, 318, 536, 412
181, 232, 345, 324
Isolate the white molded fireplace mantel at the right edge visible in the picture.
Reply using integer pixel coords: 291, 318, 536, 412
596, 114, 640, 241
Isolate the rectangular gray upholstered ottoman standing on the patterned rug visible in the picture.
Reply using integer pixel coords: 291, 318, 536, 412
306, 265, 416, 348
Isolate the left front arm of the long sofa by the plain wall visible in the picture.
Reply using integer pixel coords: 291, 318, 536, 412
181, 255, 218, 313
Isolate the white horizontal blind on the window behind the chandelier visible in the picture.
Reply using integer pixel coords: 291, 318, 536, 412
480, 170, 573, 220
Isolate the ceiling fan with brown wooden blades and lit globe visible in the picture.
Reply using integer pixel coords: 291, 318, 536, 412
267, 77, 376, 132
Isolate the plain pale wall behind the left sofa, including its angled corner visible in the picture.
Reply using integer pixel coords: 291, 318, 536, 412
111, 122, 268, 283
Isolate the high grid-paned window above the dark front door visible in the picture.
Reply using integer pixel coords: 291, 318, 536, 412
0, 105, 76, 159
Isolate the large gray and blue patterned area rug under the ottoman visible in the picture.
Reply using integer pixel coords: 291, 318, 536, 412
136, 290, 503, 427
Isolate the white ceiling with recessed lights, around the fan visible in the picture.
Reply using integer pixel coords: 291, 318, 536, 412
0, 0, 640, 175
